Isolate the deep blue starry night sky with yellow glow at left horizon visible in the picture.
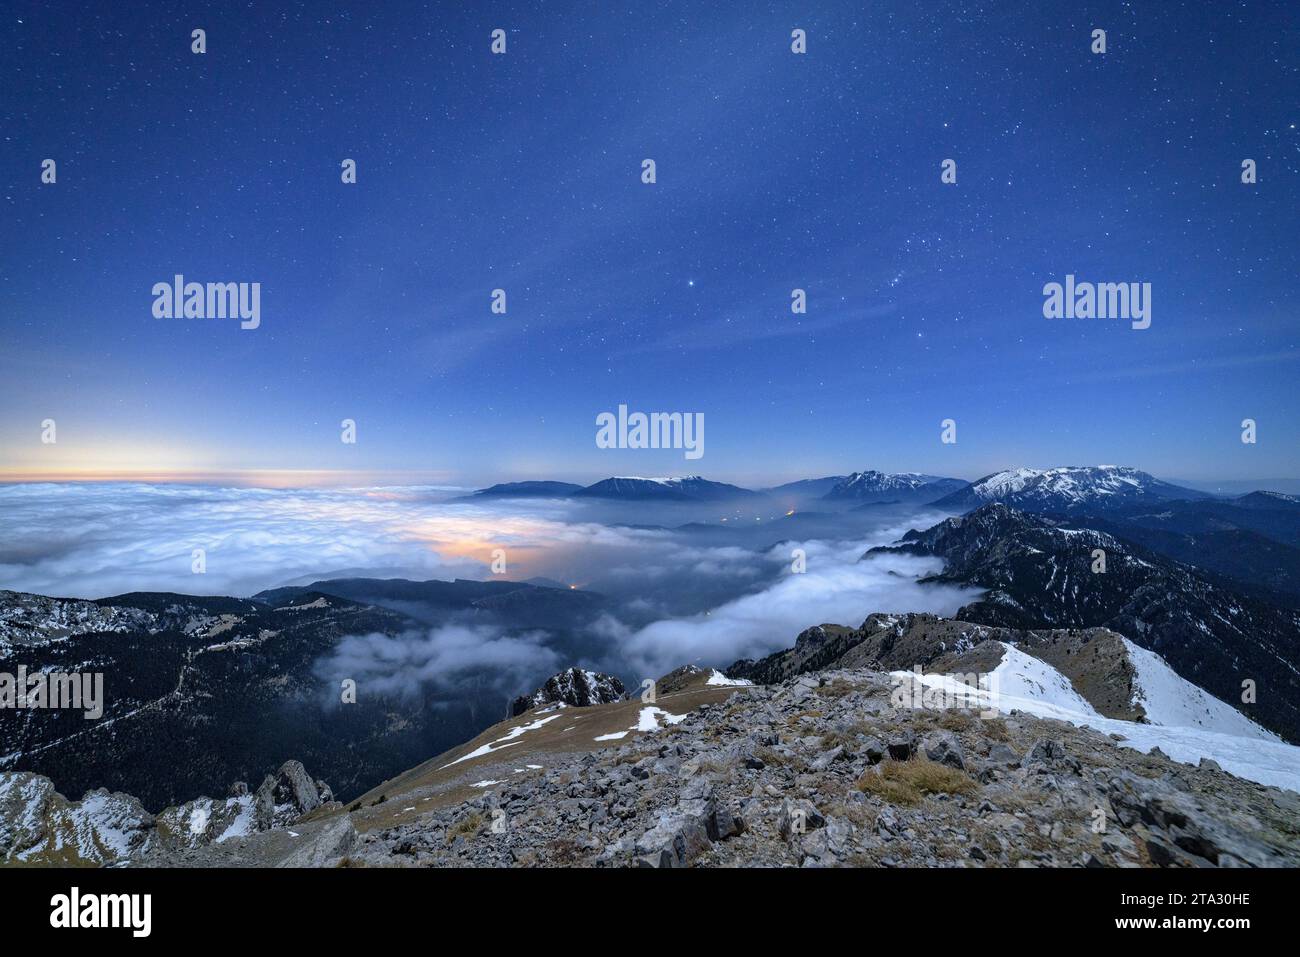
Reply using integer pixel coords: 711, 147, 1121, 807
0, 0, 1300, 484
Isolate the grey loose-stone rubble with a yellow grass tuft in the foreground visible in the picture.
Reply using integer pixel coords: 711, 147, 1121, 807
346, 671, 1300, 867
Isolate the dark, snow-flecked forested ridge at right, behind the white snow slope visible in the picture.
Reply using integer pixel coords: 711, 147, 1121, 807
868, 505, 1300, 741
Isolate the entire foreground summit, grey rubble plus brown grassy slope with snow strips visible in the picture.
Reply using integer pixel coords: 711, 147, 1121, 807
0, 668, 1300, 867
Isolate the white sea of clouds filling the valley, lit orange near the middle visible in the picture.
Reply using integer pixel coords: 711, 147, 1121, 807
0, 484, 974, 690
